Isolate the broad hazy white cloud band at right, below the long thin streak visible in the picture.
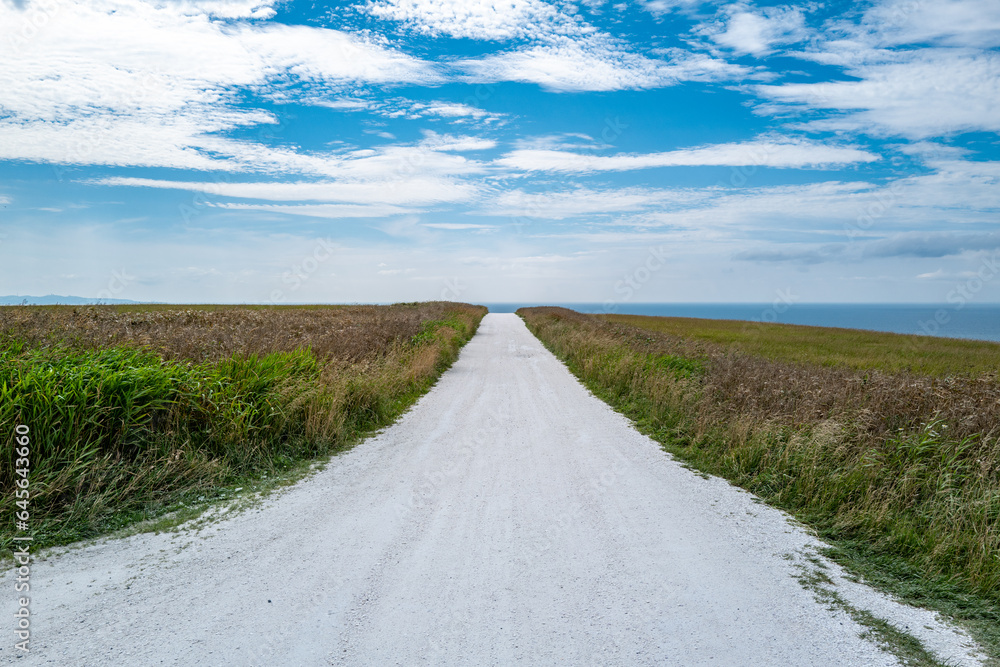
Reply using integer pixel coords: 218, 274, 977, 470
488, 154, 1000, 237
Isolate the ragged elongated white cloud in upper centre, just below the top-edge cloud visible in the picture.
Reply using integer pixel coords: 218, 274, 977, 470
456, 35, 751, 92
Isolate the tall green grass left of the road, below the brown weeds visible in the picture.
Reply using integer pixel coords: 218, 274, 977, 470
0, 307, 485, 549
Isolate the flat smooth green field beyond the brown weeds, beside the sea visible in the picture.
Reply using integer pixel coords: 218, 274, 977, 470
601, 315, 1000, 377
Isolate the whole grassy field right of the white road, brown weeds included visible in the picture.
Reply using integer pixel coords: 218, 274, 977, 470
518, 308, 1000, 659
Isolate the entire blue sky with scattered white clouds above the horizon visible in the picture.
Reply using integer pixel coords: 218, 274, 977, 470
0, 0, 1000, 304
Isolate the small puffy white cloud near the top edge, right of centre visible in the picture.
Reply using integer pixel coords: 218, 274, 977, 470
698, 5, 809, 56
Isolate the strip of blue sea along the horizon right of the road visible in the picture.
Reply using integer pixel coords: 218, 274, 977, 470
484, 303, 1000, 342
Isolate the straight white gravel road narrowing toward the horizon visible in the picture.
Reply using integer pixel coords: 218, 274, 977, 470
0, 315, 978, 667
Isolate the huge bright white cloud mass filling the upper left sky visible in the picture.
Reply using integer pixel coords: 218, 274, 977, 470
0, 0, 439, 170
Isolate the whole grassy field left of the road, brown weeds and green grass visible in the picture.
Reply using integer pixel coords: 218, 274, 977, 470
0, 303, 486, 548
